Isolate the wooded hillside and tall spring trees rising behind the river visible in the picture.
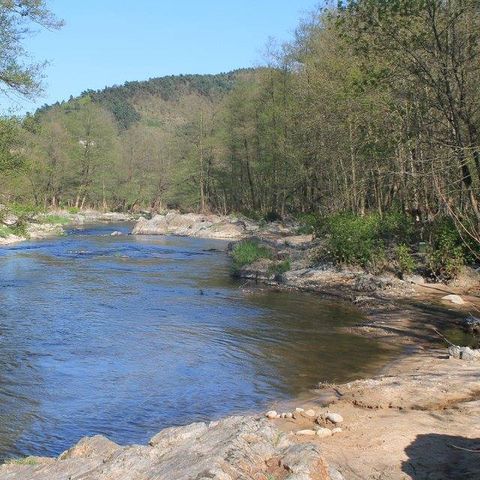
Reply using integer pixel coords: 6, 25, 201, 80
1, 0, 480, 255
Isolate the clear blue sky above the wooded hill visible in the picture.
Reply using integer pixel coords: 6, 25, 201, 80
0, 0, 318, 113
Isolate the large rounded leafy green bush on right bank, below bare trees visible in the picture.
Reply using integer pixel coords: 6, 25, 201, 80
320, 213, 385, 268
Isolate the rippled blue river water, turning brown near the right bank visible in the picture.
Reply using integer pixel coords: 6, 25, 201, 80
0, 225, 394, 458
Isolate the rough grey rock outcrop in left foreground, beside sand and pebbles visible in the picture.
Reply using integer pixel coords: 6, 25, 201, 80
0, 416, 342, 480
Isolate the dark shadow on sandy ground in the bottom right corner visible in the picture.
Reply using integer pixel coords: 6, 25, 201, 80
402, 433, 480, 480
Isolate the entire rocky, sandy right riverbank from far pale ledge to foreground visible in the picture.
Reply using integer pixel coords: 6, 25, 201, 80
0, 214, 480, 480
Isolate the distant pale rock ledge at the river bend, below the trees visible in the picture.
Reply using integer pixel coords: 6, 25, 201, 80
132, 212, 251, 240
